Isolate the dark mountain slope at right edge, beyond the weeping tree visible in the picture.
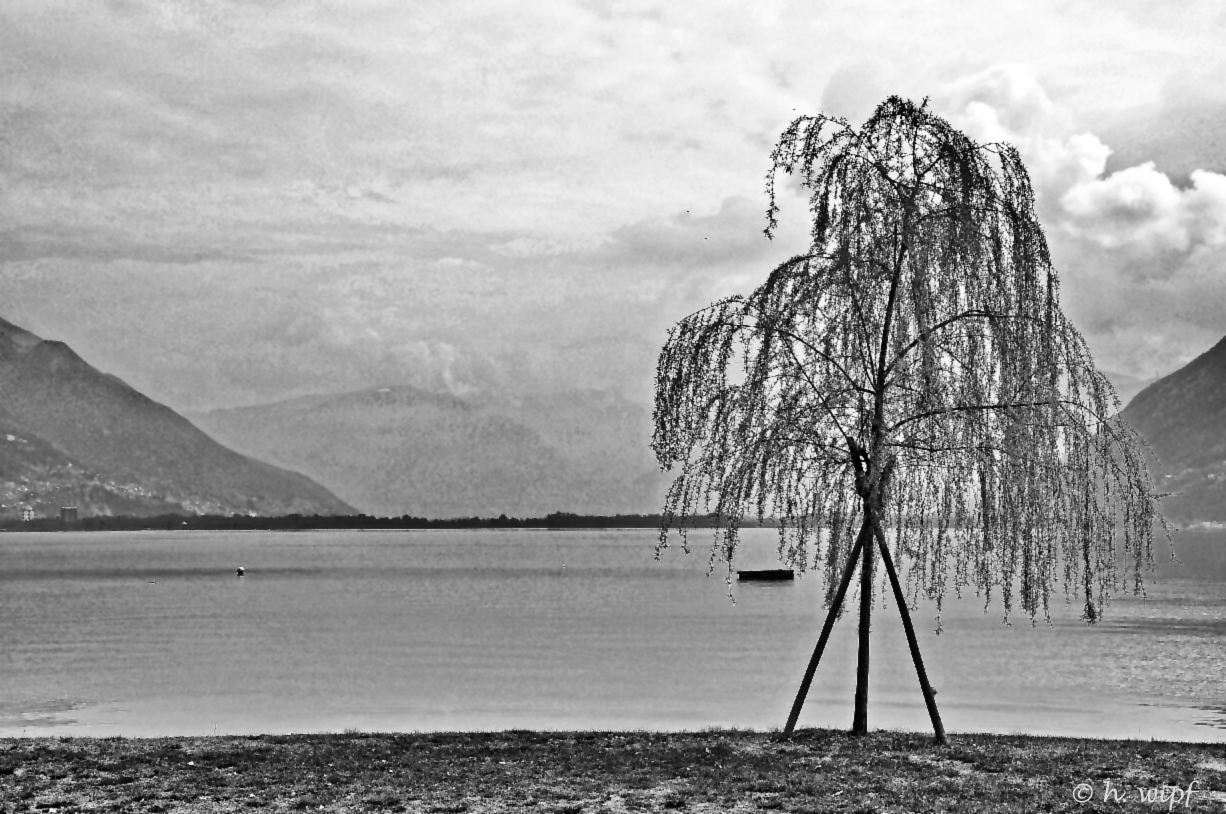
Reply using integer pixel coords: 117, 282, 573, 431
1122, 338, 1226, 523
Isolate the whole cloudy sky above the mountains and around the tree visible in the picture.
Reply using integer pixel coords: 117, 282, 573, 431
0, 0, 1226, 411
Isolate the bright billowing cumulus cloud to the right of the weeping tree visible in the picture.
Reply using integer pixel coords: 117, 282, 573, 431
926, 65, 1226, 379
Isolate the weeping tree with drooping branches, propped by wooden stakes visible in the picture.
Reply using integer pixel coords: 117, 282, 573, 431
652, 97, 1161, 740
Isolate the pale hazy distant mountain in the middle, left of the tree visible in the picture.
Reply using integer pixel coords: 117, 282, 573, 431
191, 386, 667, 519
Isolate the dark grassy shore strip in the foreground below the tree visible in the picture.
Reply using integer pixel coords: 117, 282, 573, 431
0, 729, 1226, 814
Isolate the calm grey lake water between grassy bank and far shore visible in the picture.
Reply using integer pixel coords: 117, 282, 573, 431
0, 530, 1226, 742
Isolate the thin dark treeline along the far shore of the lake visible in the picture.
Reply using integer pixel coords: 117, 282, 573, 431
0, 511, 774, 531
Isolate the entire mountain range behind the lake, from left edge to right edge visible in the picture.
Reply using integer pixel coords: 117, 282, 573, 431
0, 308, 1226, 525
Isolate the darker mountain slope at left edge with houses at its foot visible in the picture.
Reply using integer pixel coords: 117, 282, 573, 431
0, 320, 352, 515
